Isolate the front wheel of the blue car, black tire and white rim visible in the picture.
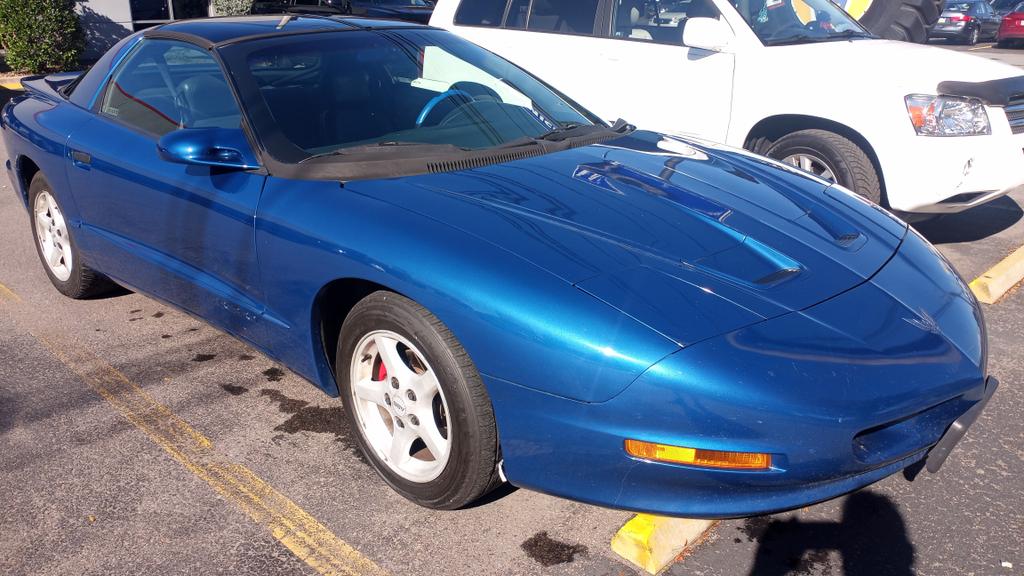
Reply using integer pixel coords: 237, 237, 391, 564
336, 291, 498, 509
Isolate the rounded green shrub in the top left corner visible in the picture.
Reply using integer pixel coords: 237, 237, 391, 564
0, 0, 83, 73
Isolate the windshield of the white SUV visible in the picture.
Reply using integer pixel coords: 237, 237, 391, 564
732, 0, 872, 46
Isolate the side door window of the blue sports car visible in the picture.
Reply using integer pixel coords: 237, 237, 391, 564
99, 40, 242, 136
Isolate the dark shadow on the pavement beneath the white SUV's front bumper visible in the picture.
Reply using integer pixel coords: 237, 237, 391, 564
913, 196, 1024, 244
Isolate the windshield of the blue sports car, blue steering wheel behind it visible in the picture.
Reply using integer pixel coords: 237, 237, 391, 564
224, 28, 603, 161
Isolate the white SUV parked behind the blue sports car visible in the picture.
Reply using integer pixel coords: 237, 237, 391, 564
430, 0, 1024, 213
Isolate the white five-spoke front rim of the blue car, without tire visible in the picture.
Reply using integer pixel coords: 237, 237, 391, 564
349, 330, 453, 483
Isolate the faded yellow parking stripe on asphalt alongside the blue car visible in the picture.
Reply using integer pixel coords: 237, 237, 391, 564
33, 334, 386, 576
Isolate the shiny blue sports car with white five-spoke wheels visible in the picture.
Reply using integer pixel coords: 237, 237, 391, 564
2, 15, 996, 518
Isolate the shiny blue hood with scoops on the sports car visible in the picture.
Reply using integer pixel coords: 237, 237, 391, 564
346, 132, 906, 345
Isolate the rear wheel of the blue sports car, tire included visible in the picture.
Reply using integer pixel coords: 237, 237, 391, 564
29, 172, 111, 298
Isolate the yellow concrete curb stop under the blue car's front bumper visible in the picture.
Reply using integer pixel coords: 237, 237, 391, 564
611, 515, 718, 574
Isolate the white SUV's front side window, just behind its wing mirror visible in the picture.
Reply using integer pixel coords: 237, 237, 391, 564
612, 0, 721, 46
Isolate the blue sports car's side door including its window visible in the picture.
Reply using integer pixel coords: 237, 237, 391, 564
69, 39, 265, 336
